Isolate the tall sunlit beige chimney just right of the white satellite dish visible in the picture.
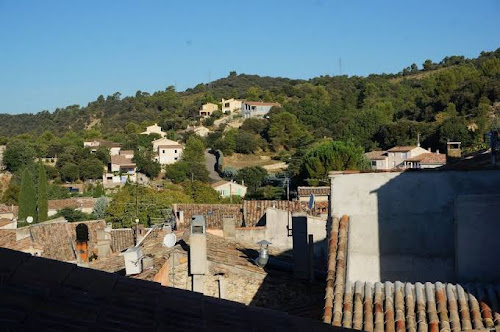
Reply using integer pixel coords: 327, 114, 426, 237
189, 215, 207, 293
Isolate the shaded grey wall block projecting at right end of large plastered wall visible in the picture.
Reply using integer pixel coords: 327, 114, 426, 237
455, 195, 500, 282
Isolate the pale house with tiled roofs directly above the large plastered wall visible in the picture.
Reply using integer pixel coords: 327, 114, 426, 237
365, 146, 429, 170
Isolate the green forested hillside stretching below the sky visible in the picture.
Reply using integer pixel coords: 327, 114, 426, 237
0, 49, 500, 151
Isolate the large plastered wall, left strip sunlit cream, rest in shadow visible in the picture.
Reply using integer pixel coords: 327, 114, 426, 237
331, 171, 500, 282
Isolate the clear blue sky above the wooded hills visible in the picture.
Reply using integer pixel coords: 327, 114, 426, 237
0, 0, 500, 114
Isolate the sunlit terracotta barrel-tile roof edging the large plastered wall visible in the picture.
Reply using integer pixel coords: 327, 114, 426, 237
323, 216, 500, 332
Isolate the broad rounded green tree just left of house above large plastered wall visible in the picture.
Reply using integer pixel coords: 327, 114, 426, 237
301, 141, 369, 181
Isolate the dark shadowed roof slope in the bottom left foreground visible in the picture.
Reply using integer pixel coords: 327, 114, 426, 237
0, 248, 334, 331
